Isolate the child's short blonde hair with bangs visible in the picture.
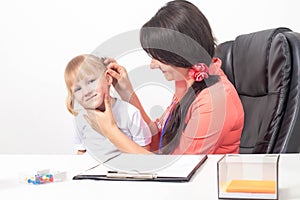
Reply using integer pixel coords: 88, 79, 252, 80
64, 54, 106, 115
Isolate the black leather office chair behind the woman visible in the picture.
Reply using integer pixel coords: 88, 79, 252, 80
215, 28, 300, 153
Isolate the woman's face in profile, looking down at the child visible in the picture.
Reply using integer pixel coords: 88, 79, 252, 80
150, 59, 188, 81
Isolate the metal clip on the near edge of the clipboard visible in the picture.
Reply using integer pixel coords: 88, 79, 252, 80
106, 171, 157, 180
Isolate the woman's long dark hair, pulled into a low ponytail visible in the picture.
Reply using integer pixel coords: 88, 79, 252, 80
140, 0, 218, 154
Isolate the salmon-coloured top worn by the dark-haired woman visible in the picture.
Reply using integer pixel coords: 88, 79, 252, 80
157, 68, 244, 154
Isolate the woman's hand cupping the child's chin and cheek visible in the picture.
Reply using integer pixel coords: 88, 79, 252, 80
84, 95, 117, 137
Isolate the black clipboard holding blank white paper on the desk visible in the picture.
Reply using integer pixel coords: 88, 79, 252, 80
73, 153, 207, 182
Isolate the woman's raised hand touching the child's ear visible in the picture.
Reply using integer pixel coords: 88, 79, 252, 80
107, 62, 134, 102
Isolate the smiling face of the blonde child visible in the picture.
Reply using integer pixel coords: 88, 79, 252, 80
72, 72, 110, 109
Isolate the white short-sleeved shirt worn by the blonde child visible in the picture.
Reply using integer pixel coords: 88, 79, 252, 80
74, 99, 152, 162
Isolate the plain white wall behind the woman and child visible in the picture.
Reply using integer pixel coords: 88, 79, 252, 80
0, 0, 300, 154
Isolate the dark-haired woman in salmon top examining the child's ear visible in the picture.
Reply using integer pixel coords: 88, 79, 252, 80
86, 0, 244, 154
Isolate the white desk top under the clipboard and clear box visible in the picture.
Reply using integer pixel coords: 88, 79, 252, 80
0, 154, 300, 200
